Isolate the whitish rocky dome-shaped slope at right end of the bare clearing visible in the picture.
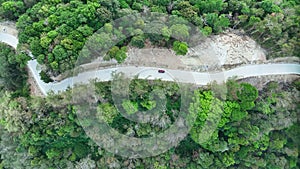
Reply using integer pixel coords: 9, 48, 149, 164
186, 32, 266, 66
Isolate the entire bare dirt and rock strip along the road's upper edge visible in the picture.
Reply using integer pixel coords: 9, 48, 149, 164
120, 31, 266, 72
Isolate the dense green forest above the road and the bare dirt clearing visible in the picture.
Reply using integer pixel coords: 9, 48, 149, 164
7, 0, 300, 78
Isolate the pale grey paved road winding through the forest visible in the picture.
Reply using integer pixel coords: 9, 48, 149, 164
0, 33, 300, 95
